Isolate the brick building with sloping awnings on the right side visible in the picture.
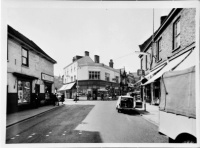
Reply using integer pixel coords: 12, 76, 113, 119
139, 8, 196, 103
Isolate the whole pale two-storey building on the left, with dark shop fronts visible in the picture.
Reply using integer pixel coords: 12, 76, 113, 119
7, 26, 56, 113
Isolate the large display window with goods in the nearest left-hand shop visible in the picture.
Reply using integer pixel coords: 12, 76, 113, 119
17, 80, 31, 104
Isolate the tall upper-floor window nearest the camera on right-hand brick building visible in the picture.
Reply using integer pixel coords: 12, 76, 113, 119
173, 19, 181, 49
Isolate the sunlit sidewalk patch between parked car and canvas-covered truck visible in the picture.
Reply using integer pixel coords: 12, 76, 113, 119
136, 103, 159, 126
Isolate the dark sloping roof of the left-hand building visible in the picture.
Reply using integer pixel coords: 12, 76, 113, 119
8, 25, 57, 64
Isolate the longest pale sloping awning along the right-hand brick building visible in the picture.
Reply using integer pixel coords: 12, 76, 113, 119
142, 51, 191, 85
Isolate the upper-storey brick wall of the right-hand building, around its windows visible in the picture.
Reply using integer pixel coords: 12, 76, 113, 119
153, 8, 196, 67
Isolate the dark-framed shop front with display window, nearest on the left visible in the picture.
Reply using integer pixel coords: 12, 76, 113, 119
7, 72, 38, 113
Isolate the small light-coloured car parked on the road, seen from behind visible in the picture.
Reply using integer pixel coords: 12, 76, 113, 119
116, 95, 135, 112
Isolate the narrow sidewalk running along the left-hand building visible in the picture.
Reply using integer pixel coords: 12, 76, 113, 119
6, 102, 64, 127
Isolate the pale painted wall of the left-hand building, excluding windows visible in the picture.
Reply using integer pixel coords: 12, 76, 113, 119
7, 39, 54, 93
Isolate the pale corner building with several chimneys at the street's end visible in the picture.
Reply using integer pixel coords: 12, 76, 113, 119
60, 51, 120, 100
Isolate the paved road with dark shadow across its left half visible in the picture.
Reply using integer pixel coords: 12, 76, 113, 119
6, 101, 167, 143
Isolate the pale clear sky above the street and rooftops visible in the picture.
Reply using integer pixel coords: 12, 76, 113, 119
4, 0, 182, 76
